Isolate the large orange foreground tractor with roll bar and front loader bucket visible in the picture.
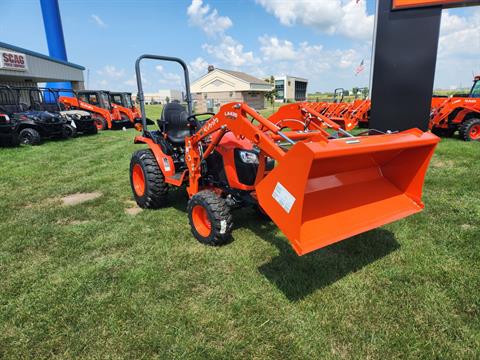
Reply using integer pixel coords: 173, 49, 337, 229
130, 55, 439, 255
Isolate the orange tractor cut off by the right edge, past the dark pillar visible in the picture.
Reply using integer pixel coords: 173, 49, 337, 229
429, 76, 480, 141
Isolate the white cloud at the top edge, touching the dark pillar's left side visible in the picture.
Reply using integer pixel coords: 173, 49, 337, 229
256, 0, 374, 40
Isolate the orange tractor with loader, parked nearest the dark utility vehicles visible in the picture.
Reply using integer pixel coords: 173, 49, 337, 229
58, 90, 124, 130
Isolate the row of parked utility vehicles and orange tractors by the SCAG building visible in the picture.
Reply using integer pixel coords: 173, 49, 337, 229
0, 86, 146, 146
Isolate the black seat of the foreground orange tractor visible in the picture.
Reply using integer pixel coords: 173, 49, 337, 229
158, 102, 190, 146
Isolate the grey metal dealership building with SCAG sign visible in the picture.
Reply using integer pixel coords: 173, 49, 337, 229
0, 42, 85, 102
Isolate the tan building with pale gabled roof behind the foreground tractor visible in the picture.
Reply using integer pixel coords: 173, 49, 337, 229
190, 65, 273, 112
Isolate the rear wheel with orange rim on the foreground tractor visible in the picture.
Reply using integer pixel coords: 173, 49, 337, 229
130, 149, 168, 209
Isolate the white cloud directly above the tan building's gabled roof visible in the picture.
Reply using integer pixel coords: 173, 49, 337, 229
202, 36, 260, 68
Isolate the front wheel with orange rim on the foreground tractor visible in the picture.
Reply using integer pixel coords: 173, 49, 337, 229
187, 190, 233, 246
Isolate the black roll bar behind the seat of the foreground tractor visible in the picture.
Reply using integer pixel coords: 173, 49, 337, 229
135, 54, 193, 135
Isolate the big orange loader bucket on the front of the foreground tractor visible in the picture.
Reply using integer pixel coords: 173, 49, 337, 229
256, 129, 440, 255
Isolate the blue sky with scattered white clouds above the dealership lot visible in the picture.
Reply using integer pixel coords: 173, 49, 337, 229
0, 0, 480, 91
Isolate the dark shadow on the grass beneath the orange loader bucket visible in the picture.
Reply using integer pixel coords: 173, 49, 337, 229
242, 211, 400, 302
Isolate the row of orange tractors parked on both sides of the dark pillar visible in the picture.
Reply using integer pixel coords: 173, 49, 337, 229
302, 76, 480, 141
